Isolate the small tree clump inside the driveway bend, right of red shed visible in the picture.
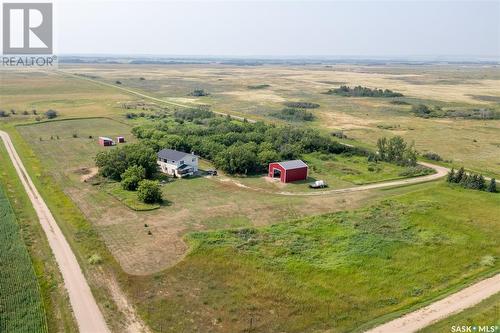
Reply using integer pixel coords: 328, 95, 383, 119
368, 136, 418, 167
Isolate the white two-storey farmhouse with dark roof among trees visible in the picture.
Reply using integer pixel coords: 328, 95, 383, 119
157, 149, 198, 177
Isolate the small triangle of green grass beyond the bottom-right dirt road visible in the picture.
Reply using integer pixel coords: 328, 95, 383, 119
420, 294, 500, 333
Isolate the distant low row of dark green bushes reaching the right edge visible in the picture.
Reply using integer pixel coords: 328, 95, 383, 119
411, 104, 500, 119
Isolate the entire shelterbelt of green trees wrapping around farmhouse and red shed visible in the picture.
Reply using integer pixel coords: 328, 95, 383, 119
96, 109, 431, 189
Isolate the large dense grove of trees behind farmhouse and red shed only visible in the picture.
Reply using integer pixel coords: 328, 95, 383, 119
133, 110, 360, 174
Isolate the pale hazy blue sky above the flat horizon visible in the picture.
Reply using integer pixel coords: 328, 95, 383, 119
54, 0, 500, 59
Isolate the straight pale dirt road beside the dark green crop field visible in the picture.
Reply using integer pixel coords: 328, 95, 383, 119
0, 131, 109, 333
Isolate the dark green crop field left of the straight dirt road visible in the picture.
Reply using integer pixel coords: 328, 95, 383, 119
0, 187, 48, 333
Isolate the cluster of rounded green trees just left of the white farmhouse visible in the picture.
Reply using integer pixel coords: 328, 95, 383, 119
95, 143, 162, 203
